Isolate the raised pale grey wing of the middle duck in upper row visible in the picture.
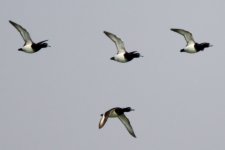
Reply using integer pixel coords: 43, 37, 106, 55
104, 31, 126, 53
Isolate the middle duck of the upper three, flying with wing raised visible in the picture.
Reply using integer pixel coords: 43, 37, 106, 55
104, 31, 143, 63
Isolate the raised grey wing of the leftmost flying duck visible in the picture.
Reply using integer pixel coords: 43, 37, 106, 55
9, 20, 32, 44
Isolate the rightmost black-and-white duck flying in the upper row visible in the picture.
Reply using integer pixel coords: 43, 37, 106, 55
171, 28, 212, 53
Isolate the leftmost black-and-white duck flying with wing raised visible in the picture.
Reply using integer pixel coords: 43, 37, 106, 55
9, 20, 50, 53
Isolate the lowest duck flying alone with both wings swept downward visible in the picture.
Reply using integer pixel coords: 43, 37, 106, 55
99, 107, 136, 138
